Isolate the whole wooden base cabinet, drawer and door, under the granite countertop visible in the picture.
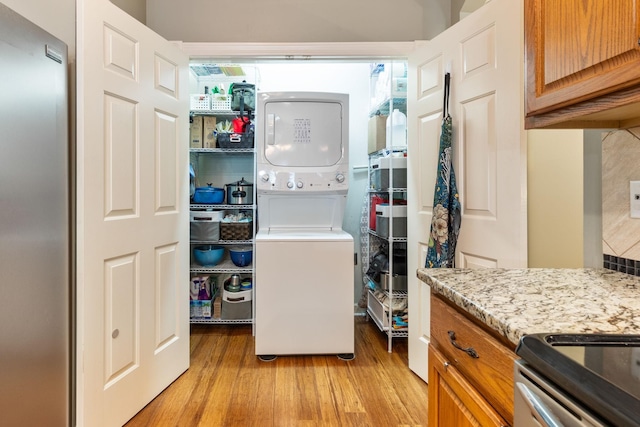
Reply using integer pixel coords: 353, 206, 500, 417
429, 295, 516, 426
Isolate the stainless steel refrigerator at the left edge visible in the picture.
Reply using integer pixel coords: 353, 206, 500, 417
0, 3, 72, 427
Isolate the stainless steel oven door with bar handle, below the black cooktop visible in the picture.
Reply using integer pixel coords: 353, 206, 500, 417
514, 360, 606, 427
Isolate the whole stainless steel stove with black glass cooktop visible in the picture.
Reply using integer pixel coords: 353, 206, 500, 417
514, 334, 640, 427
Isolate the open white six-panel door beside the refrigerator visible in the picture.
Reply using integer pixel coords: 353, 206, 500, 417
76, 0, 189, 427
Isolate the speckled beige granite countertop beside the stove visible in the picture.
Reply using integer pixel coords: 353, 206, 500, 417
417, 268, 640, 345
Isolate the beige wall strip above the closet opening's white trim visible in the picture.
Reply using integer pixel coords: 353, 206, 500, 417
147, 0, 451, 42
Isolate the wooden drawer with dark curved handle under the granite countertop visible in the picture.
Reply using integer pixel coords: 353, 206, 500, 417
431, 296, 516, 424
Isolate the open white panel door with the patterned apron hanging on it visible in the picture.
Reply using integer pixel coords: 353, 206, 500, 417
407, 0, 527, 381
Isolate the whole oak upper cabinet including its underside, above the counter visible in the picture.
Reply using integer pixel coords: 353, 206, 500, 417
524, 0, 640, 129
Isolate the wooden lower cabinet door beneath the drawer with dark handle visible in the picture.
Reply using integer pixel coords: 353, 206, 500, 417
428, 345, 507, 427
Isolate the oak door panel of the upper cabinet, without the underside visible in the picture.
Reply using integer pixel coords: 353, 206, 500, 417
525, 0, 640, 116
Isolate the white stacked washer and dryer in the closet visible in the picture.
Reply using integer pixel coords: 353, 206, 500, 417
255, 92, 354, 360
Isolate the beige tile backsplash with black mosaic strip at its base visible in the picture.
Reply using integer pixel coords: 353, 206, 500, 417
602, 127, 640, 275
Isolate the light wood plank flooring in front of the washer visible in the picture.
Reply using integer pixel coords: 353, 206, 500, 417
126, 317, 427, 427
